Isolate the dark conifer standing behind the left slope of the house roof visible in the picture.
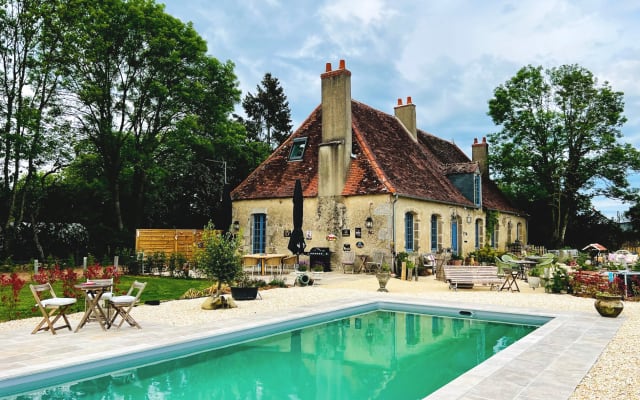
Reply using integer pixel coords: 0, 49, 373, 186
242, 72, 293, 148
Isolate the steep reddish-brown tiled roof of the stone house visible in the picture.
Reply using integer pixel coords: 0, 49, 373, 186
232, 100, 517, 212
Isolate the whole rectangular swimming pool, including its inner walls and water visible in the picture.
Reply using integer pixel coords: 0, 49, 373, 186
1, 303, 550, 398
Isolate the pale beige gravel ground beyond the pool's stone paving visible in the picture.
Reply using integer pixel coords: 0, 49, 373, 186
0, 273, 640, 400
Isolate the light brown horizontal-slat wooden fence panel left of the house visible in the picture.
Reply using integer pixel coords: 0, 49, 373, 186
136, 229, 202, 261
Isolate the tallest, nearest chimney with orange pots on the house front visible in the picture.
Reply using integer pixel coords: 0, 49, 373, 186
318, 60, 352, 196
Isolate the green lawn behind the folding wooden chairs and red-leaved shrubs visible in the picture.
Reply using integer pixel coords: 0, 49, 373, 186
0, 275, 212, 322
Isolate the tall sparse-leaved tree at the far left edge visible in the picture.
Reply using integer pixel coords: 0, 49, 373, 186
0, 0, 72, 255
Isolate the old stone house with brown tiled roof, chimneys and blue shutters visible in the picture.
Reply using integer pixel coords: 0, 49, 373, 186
231, 60, 527, 266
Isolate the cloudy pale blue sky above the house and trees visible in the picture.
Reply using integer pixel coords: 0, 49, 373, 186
156, 0, 640, 218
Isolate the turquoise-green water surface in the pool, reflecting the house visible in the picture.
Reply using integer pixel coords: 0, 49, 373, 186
6, 305, 546, 399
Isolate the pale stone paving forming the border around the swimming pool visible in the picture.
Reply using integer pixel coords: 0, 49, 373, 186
0, 294, 623, 400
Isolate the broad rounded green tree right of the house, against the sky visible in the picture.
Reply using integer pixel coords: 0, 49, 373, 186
488, 65, 640, 246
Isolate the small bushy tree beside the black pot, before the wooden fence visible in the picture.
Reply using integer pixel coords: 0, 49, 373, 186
195, 222, 242, 295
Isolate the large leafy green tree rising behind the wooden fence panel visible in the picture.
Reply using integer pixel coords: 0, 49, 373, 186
60, 0, 234, 230
